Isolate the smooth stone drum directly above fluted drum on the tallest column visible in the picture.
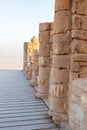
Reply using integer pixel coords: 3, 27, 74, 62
51, 68, 69, 84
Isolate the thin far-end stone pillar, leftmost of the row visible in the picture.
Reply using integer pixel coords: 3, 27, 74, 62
23, 42, 28, 75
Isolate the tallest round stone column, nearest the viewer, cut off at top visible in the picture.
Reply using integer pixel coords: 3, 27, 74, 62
49, 0, 71, 128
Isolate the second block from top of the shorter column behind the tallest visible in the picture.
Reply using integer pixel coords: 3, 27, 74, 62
39, 31, 50, 44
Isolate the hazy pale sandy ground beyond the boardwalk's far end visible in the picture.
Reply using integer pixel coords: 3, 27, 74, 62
0, 56, 23, 69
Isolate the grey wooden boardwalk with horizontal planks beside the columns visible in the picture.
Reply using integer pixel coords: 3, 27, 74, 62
0, 70, 58, 130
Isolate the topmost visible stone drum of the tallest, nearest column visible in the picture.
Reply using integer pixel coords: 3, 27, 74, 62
55, 0, 71, 12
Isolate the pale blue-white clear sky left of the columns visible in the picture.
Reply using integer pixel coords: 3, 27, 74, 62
0, 0, 54, 56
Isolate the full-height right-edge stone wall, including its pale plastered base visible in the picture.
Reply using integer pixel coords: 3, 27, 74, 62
68, 0, 87, 130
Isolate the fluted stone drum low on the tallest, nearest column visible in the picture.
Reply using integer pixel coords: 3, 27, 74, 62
50, 83, 68, 98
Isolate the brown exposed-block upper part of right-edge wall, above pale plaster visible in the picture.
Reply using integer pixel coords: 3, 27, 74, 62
70, 0, 87, 80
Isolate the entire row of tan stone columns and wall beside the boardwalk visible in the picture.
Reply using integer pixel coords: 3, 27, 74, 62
23, 0, 87, 130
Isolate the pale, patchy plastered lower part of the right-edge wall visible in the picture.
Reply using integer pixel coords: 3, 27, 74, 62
68, 78, 87, 130
